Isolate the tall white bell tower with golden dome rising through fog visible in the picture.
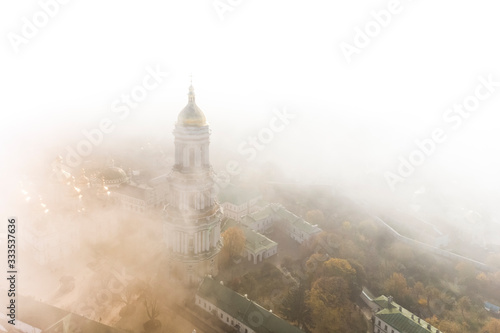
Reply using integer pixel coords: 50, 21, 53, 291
164, 86, 222, 283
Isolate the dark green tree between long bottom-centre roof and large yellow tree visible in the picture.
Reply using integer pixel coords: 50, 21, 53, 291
280, 281, 311, 329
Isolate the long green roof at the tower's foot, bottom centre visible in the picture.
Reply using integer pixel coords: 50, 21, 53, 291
197, 277, 303, 333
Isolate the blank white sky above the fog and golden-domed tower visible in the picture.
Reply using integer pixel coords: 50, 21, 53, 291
0, 0, 500, 210
